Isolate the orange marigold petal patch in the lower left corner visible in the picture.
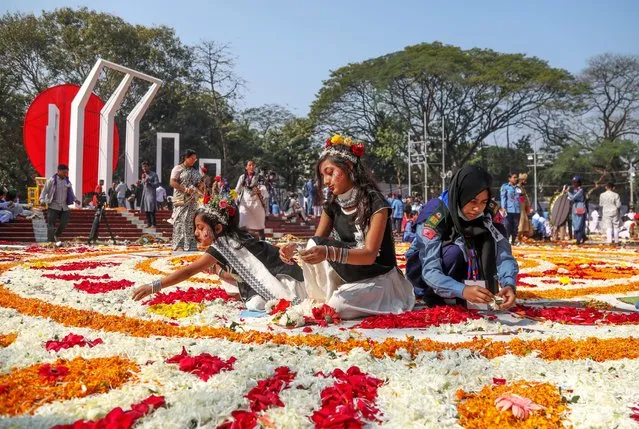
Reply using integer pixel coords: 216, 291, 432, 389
0, 356, 139, 416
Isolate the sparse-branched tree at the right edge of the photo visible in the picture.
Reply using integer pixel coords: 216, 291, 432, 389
526, 53, 639, 199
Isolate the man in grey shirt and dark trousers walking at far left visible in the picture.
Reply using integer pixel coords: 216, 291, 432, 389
40, 164, 80, 242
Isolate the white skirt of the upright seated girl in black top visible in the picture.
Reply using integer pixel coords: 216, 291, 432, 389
302, 240, 415, 319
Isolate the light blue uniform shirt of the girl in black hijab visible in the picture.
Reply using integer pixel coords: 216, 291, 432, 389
406, 192, 519, 298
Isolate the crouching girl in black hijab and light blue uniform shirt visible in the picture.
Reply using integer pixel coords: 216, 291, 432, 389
406, 165, 519, 309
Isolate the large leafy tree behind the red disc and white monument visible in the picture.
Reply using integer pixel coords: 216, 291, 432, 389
0, 8, 192, 194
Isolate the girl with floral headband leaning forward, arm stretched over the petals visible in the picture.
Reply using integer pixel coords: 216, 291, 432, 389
133, 190, 306, 310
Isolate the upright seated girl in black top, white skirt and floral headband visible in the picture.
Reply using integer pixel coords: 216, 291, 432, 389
280, 135, 415, 319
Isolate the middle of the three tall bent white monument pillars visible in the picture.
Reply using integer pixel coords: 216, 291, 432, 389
98, 73, 133, 189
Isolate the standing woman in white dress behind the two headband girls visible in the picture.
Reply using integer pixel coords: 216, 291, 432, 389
235, 160, 268, 240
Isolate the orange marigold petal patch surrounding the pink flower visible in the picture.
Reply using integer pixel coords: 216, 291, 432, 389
457, 381, 568, 429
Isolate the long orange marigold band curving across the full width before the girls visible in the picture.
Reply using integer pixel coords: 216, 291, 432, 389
0, 285, 639, 362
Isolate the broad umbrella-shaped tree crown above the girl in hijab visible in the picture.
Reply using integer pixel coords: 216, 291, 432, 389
311, 43, 574, 186
